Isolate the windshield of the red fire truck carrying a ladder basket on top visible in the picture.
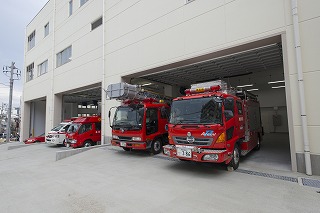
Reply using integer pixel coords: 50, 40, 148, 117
113, 105, 144, 129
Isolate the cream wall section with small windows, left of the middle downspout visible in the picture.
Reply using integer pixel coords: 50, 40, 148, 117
22, 0, 103, 140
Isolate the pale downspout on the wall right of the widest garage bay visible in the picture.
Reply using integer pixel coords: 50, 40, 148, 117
291, 0, 312, 175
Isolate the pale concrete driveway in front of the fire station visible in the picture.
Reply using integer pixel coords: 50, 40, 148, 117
0, 144, 320, 213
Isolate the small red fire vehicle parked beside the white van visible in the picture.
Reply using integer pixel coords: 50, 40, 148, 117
65, 116, 101, 148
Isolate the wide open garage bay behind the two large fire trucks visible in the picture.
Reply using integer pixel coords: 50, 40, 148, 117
124, 38, 291, 171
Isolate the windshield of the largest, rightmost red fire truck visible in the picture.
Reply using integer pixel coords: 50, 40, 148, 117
169, 97, 222, 124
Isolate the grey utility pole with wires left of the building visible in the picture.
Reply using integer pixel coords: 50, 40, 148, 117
3, 62, 21, 142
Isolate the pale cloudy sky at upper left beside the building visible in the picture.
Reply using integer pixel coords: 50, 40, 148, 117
0, 0, 48, 107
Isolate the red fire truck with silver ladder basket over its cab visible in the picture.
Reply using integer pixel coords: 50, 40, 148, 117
107, 83, 170, 154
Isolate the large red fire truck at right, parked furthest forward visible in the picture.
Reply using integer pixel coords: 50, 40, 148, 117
163, 80, 263, 170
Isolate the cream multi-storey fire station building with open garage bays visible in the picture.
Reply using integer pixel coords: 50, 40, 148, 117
21, 0, 320, 175
